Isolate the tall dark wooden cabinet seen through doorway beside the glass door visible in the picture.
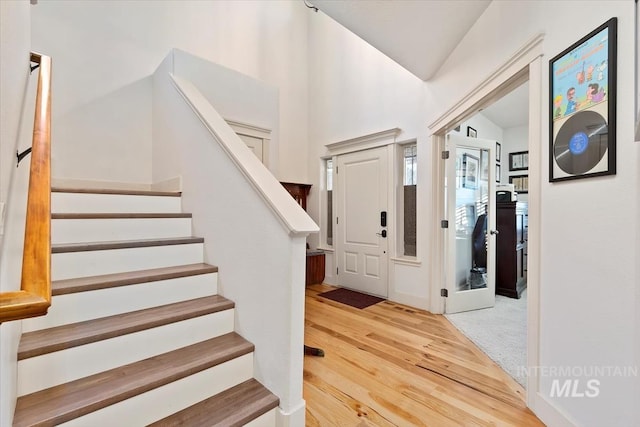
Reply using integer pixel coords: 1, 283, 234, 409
496, 202, 527, 298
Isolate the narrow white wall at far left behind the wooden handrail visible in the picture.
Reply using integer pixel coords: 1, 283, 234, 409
0, 1, 35, 426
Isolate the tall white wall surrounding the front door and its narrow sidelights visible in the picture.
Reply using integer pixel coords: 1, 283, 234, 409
307, 12, 431, 308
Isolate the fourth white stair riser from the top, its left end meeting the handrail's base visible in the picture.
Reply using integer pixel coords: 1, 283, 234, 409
22, 273, 218, 332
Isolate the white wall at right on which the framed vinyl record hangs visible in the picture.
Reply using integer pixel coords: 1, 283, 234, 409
428, 1, 639, 426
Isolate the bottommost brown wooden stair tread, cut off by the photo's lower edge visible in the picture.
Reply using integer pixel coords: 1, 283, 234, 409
148, 379, 280, 427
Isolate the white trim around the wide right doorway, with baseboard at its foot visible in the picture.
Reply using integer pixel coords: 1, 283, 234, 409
429, 34, 575, 426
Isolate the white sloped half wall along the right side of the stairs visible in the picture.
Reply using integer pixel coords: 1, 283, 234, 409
153, 55, 317, 425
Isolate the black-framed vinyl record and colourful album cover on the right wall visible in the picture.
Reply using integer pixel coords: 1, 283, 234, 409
549, 18, 618, 182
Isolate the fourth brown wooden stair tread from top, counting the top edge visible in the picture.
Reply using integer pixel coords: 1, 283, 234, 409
51, 263, 218, 296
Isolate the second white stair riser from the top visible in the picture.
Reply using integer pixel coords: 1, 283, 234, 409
51, 218, 191, 244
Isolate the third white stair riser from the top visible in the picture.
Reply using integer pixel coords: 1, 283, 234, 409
51, 243, 203, 280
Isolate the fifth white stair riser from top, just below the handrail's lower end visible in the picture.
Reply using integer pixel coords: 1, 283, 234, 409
18, 309, 234, 396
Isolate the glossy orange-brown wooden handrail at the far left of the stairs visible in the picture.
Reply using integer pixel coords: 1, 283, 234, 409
0, 52, 51, 322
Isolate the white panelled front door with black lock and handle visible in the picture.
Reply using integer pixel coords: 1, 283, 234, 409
334, 147, 390, 298
